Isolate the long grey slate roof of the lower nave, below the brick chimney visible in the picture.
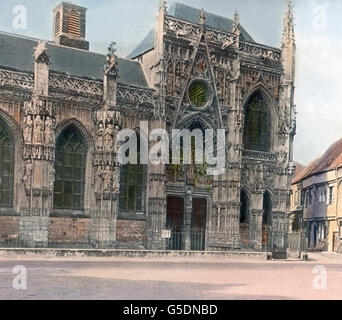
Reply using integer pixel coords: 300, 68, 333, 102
0, 32, 148, 87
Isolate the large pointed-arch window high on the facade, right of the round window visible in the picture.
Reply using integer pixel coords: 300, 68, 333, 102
243, 92, 270, 152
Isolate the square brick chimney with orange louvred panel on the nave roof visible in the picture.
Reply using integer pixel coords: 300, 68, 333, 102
53, 2, 89, 50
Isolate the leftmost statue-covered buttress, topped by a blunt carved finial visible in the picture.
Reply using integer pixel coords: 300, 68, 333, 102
19, 42, 56, 247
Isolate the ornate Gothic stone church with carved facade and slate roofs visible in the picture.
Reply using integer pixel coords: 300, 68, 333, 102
0, 1, 296, 250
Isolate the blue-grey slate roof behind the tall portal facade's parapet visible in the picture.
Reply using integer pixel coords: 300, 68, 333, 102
128, 2, 255, 59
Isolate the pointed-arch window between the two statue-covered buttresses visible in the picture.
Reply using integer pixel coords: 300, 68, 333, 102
54, 126, 87, 210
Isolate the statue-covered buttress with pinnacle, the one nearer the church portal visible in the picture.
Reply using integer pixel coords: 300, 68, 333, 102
90, 42, 121, 248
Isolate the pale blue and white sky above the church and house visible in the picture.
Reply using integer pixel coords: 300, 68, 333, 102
0, 0, 342, 164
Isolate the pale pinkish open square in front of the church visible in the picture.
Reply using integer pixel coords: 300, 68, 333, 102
0, 254, 342, 300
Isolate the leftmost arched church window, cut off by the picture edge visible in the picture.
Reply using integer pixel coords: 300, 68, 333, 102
0, 118, 14, 207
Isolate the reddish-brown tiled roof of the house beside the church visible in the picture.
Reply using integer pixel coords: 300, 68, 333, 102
292, 139, 342, 184
